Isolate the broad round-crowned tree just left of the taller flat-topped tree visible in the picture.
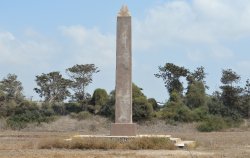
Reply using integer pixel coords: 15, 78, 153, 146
34, 72, 71, 103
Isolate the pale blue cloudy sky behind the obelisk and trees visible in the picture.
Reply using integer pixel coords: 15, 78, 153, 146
0, 0, 250, 102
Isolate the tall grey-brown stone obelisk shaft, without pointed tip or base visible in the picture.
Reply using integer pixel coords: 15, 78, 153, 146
115, 16, 132, 123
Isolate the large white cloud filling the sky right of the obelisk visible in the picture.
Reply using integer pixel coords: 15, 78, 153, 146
134, 0, 250, 60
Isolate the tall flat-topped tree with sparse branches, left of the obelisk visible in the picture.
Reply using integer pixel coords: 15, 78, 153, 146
66, 64, 99, 101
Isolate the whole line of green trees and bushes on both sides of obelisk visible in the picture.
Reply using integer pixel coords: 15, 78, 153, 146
0, 63, 250, 131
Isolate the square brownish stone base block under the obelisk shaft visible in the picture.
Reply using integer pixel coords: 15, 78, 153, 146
110, 123, 137, 136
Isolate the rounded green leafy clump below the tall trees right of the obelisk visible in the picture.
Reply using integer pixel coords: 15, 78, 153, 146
186, 81, 206, 109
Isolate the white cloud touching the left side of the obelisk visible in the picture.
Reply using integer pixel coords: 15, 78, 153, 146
60, 26, 115, 66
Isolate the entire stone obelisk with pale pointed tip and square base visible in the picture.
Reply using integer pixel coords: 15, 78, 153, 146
111, 6, 136, 136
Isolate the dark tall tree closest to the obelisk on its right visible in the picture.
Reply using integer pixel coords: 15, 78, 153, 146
155, 63, 189, 94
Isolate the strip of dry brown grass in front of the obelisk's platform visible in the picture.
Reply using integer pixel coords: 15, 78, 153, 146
38, 137, 176, 150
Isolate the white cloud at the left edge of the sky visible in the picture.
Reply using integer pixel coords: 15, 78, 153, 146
0, 31, 58, 66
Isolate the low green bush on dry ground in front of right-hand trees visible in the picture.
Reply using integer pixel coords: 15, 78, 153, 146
197, 115, 228, 132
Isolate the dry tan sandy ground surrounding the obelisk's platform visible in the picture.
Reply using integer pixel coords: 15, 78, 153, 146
0, 118, 250, 158
